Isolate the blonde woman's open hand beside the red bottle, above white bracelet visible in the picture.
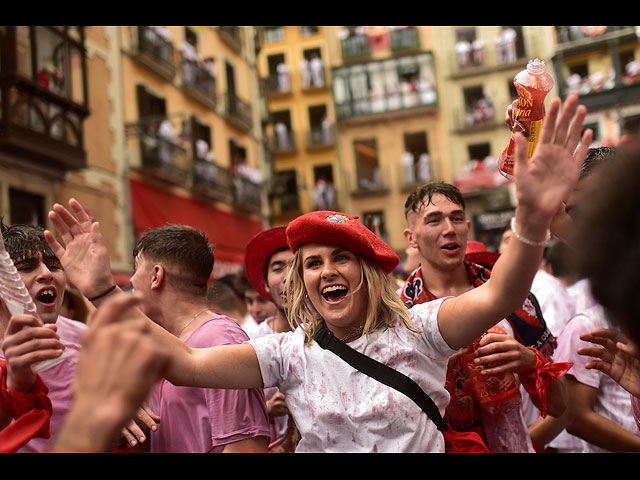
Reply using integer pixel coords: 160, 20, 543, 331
514, 95, 593, 230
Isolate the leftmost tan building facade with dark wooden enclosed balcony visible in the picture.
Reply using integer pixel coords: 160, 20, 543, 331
0, 26, 131, 270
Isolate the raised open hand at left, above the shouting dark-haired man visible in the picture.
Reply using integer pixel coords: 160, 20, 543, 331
44, 198, 114, 298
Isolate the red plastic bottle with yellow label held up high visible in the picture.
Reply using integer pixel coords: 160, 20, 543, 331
499, 58, 554, 179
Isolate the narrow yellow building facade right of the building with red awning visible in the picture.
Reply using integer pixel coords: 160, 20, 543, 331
258, 26, 345, 225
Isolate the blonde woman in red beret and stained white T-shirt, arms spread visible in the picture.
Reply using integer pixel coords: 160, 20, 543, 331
47, 96, 592, 452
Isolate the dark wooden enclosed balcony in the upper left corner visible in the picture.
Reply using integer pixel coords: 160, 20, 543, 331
0, 26, 89, 178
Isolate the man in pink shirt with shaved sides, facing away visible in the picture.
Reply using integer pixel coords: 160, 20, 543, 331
130, 225, 270, 453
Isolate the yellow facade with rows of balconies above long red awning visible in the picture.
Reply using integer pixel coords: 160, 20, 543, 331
118, 26, 264, 277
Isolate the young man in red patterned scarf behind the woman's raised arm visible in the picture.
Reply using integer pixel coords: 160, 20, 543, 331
401, 182, 564, 453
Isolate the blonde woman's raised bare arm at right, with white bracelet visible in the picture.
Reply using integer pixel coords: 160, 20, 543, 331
438, 95, 592, 348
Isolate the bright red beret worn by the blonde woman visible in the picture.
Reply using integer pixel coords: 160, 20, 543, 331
287, 211, 400, 273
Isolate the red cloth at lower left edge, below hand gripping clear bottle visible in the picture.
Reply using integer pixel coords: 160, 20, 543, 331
0, 360, 53, 453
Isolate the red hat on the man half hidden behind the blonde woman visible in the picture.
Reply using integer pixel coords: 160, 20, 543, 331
244, 225, 289, 302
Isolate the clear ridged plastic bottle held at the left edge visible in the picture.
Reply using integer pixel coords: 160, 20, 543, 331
0, 233, 69, 373
